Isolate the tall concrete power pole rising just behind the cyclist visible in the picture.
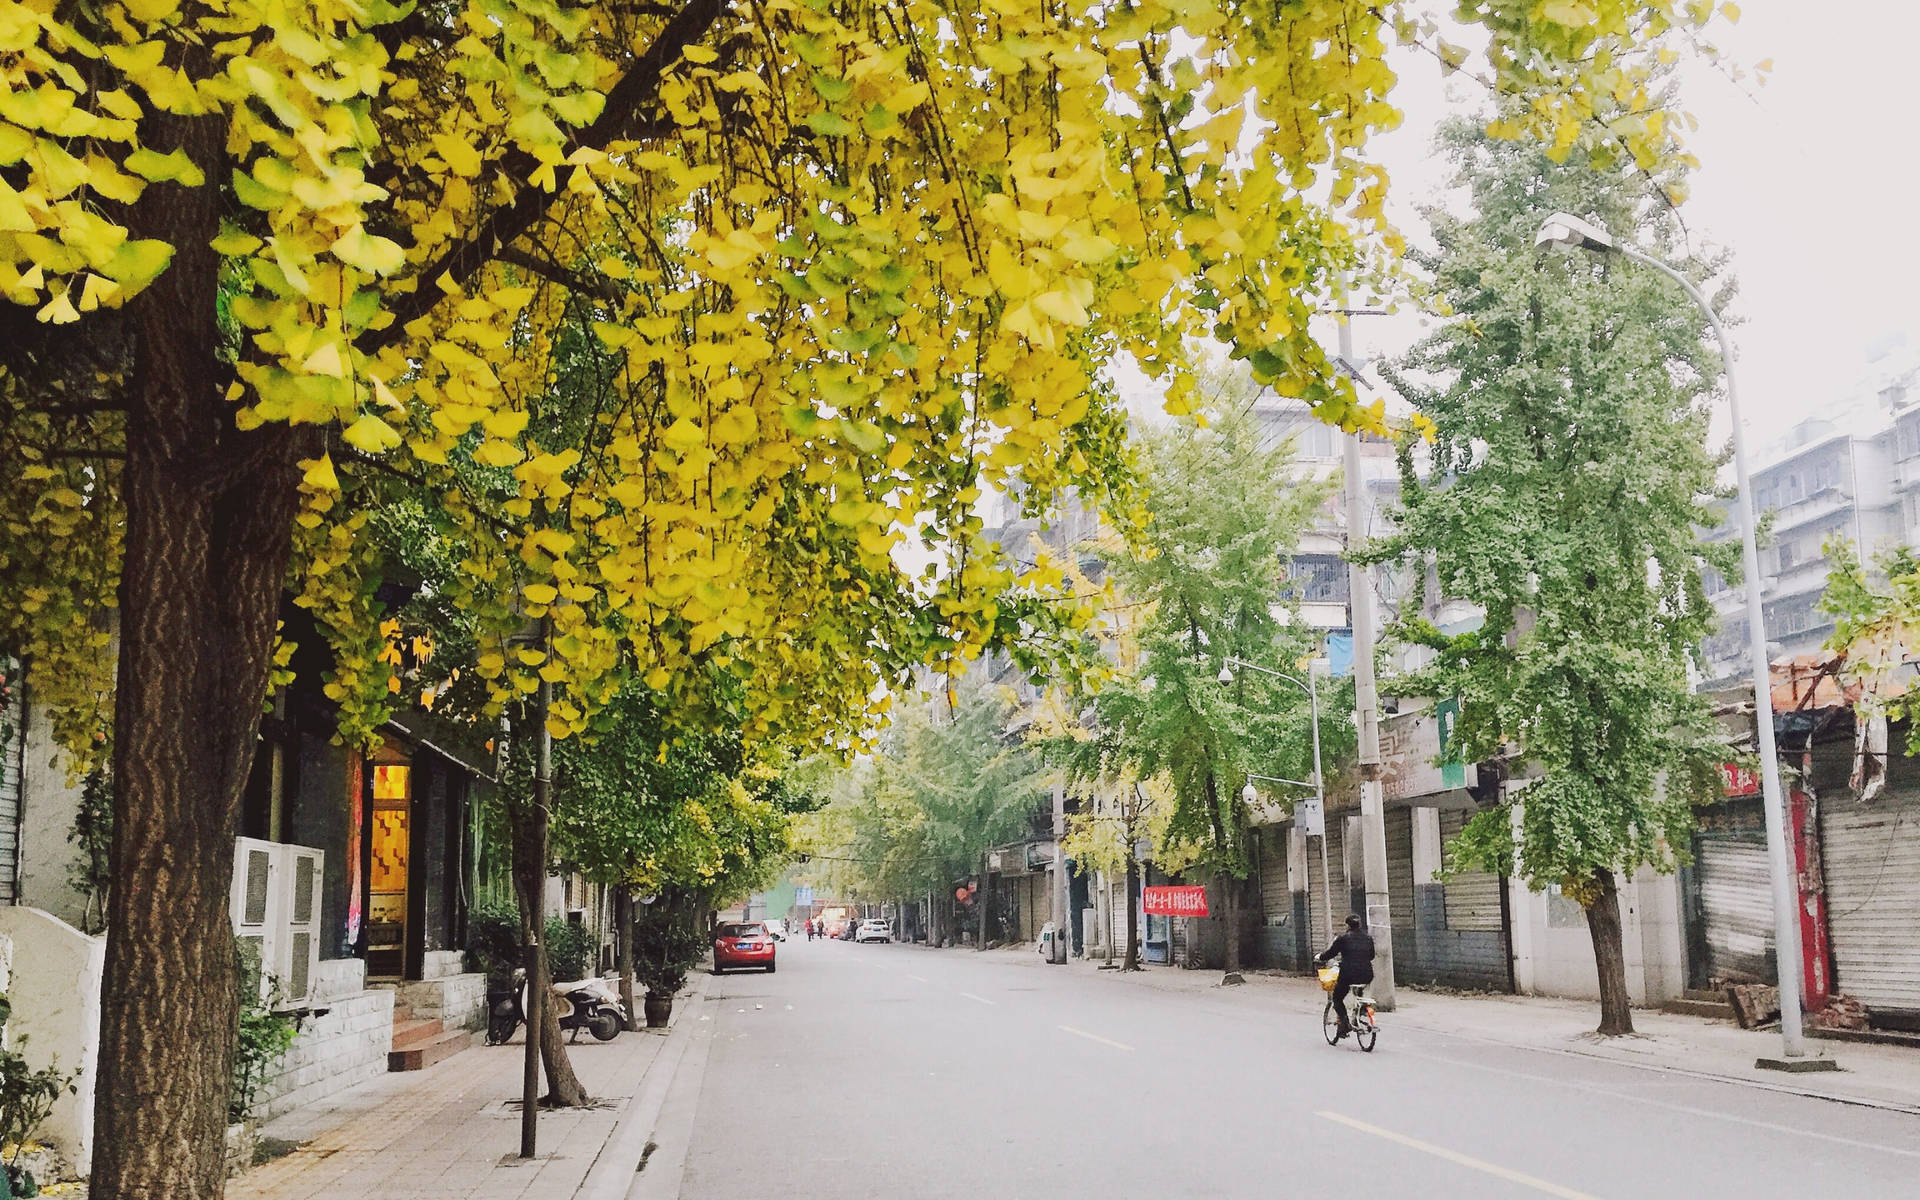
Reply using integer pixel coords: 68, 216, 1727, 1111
1338, 303, 1394, 1012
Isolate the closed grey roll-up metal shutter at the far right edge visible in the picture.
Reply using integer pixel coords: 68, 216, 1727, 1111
1820, 791, 1920, 1012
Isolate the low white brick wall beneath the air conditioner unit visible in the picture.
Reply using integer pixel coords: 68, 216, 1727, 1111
255, 958, 394, 1119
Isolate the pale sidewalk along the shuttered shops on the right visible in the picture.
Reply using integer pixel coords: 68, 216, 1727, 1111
952, 947, 1920, 1114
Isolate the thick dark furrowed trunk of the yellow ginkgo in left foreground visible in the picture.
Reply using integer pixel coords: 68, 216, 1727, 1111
92, 74, 319, 1200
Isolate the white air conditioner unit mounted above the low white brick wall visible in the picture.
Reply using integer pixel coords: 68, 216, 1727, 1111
230, 837, 326, 1008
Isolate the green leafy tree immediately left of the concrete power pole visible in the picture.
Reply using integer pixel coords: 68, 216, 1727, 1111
1050, 393, 1342, 972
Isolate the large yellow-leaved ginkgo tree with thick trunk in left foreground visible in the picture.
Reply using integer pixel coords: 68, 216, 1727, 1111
0, 0, 1732, 1196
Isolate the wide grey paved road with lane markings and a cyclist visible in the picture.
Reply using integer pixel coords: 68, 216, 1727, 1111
634, 941, 1920, 1200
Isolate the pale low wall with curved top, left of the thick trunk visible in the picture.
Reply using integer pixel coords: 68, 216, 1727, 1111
0, 904, 108, 1171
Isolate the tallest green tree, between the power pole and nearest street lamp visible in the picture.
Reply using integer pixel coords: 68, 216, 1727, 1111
1367, 109, 1736, 1035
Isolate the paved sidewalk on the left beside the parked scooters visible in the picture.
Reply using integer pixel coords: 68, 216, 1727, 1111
227, 975, 707, 1200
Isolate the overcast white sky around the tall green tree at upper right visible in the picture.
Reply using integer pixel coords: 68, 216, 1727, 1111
1329, 0, 1920, 444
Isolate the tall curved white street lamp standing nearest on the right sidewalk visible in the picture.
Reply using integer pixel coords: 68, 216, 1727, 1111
1534, 213, 1837, 1071
